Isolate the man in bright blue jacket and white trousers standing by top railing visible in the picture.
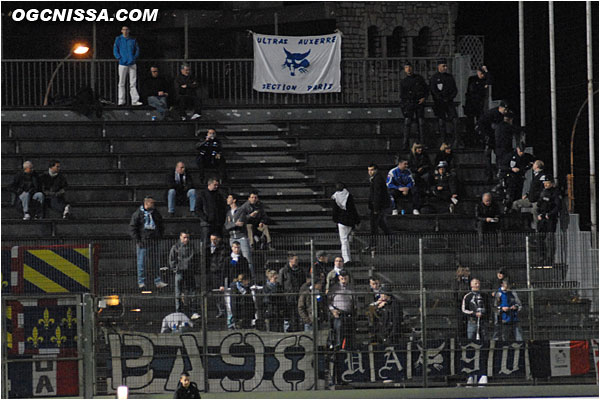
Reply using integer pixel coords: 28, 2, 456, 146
113, 26, 142, 106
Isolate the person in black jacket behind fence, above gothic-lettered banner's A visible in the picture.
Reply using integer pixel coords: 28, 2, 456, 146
375, 285, 402, 345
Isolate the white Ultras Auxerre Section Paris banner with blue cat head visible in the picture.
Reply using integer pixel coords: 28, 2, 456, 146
253, 33, 342, 93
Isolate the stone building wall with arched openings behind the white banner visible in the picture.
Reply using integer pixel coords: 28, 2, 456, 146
330, 1, 458, 58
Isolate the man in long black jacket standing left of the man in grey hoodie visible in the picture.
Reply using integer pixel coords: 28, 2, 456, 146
196, 177, 227, 246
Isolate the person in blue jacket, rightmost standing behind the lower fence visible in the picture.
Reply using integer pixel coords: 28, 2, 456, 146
494, 279, 523, 342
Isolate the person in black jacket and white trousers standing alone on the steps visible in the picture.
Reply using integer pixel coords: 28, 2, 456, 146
331, 182, 360, 263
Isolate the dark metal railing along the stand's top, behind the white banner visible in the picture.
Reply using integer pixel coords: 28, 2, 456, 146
1, 56, 471, 107
